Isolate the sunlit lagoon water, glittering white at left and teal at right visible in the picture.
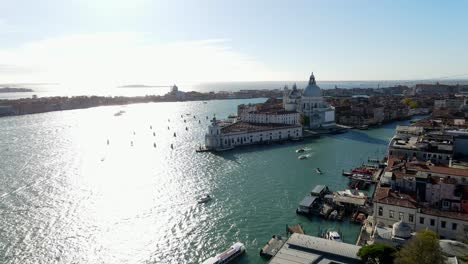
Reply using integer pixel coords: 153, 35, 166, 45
0, 99, 408, 264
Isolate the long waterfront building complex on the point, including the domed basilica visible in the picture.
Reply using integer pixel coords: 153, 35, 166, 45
203, 74, 343, 151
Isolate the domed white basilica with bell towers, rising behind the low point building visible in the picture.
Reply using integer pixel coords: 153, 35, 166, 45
283, 73, 336, 129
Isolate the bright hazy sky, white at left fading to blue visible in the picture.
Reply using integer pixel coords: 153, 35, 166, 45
0, 0, 468, 84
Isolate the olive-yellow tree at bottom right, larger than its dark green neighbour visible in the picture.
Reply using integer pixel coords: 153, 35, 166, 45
395, 230, 445, 264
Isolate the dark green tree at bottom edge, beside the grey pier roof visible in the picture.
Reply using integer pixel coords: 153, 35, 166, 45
357, 243, 397, 264
